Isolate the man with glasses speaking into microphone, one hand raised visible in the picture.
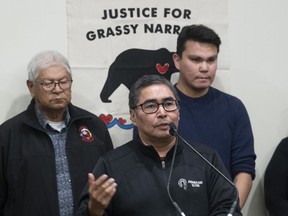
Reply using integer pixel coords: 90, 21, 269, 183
78, 75, 242, 216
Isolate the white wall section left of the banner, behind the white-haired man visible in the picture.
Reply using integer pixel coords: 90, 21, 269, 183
0, 0, 67, 123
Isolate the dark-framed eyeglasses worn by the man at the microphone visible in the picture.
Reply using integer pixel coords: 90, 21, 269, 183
131, 100, 178, 114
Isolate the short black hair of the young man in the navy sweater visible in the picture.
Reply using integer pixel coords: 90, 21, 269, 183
176, 25, 221, 57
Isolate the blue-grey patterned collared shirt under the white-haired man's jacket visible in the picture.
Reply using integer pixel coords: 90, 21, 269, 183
35, 105, 73, 216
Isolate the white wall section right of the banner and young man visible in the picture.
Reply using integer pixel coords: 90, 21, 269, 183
229, 0, 288, 216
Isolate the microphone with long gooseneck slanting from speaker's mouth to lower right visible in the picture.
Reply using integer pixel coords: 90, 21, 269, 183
169, 122, 239, 216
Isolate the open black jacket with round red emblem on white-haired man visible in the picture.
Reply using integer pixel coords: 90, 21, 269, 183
0, 99, 113, 216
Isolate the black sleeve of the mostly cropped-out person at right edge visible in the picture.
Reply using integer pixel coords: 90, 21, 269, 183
264, 138, 288, 216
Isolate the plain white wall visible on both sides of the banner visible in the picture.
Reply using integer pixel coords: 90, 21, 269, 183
0, 0, 288, 216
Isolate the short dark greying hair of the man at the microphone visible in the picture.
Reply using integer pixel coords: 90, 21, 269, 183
129, 75, 179, 109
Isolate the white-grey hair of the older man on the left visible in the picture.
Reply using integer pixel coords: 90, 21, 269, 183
27, 50, 72, 81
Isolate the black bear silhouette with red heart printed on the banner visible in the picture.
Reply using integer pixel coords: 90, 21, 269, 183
100, 48, 178, 103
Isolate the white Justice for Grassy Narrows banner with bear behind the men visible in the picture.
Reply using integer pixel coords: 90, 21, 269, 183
67, 0, 230, 147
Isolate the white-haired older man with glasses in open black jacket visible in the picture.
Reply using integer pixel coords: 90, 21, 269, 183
0, 51, 113, 216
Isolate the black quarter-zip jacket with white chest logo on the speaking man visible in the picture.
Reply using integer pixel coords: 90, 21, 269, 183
78, 138, 242, 216
